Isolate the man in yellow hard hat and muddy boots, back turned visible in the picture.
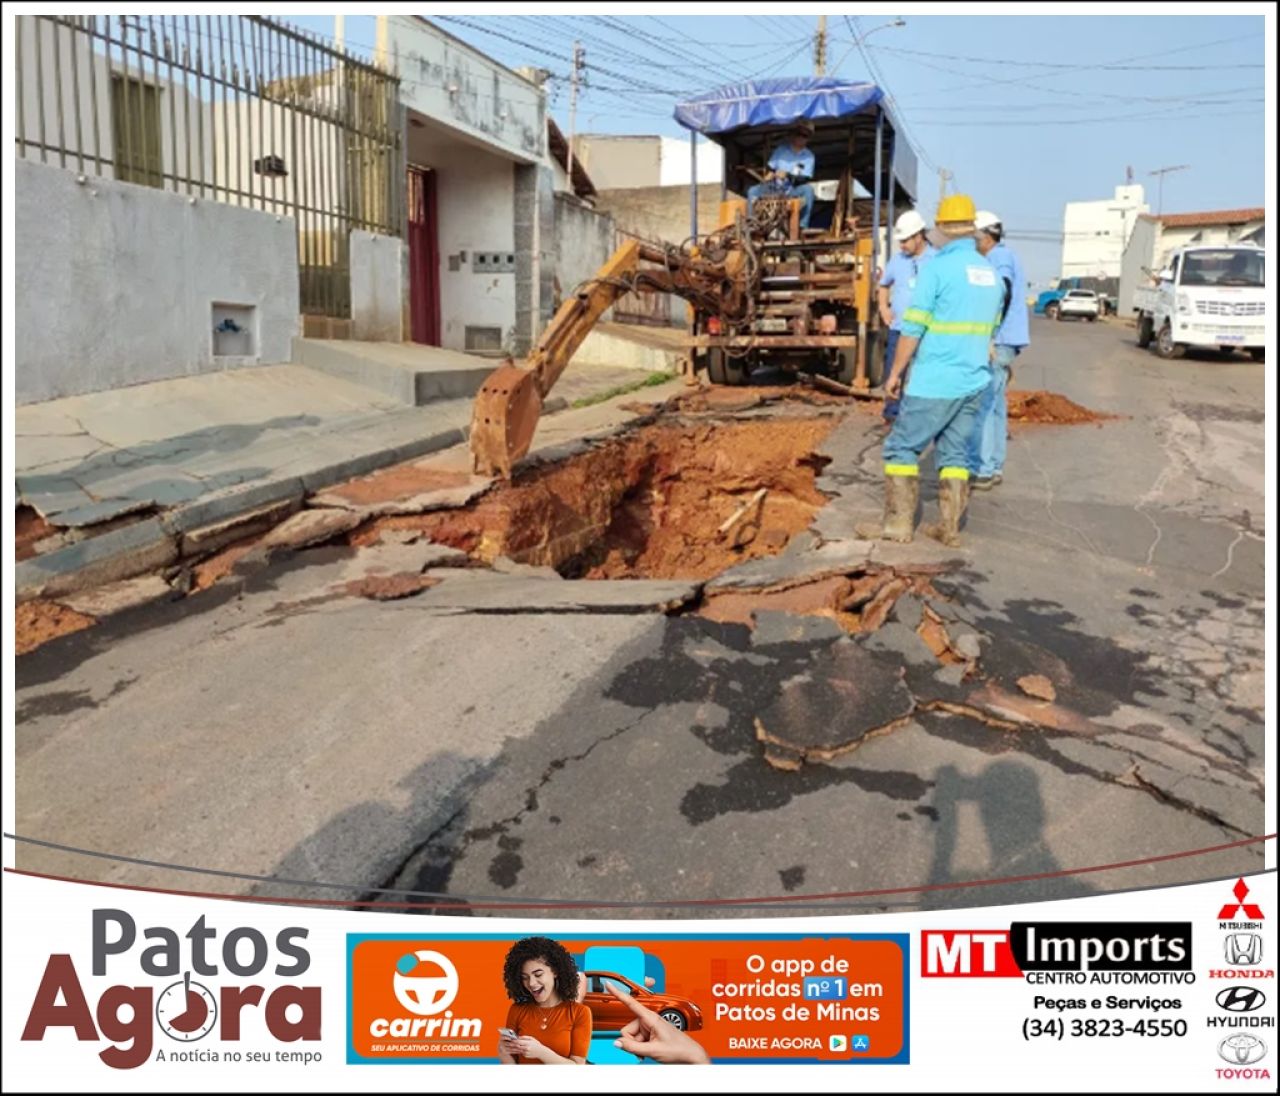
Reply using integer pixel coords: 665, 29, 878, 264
858, 195, 1004, 545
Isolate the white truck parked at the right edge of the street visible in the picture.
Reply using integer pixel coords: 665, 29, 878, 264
1133, 245, 1267, 361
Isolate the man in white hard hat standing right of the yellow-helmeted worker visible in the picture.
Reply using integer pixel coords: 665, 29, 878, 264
969, 210, 1030, 490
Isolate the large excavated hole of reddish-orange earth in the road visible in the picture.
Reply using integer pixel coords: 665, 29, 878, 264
352, 415, 838, 579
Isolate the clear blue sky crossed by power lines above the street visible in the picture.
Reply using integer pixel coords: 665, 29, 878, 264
293, 5, 1266, 282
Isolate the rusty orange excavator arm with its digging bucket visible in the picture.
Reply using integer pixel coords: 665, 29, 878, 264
471, 239, 744, 478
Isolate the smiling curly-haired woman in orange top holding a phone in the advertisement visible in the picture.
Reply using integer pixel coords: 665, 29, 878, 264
498, 936, 591, 1065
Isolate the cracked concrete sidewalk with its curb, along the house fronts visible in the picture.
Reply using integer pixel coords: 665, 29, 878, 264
15, 365, 670, 600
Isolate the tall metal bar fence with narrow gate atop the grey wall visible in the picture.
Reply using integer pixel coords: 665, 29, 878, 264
14, 15, 404, 318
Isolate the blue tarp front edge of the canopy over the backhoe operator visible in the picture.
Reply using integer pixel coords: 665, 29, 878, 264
676, 76, 884, 136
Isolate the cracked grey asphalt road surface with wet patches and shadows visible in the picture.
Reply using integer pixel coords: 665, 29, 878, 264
15, 320, 1266, 917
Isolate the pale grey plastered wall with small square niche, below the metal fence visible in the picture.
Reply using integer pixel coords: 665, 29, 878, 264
14, 160, 298, 403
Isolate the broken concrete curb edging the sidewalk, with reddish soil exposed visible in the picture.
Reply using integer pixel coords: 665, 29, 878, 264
14, 425, 476, 603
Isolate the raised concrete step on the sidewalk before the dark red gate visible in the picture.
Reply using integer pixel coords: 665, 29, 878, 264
293, 338, 498, 407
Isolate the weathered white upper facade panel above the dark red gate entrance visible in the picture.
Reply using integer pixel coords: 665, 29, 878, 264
379, 15, 547, 163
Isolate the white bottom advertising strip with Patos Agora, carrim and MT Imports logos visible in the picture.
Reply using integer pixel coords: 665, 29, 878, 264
3, 871, 1277, 1092
